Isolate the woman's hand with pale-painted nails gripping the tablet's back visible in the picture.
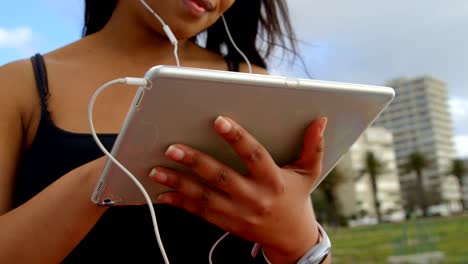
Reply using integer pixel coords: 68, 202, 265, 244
150, 117, 327, 263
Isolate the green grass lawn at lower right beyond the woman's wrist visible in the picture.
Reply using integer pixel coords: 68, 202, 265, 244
327, 216, 468, 263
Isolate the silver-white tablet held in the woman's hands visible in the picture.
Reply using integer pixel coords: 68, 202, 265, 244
92, 66, 394, 205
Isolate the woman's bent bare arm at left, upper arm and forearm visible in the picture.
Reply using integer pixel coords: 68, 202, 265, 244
0, 62, 105, 263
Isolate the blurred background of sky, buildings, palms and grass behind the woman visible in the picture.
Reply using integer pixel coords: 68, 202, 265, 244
0, 0, 468, 263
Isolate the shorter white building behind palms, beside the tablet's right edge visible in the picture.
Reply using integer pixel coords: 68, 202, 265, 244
337, 127, 404, 221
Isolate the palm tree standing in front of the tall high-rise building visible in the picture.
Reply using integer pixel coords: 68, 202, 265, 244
405, 152, 429, 217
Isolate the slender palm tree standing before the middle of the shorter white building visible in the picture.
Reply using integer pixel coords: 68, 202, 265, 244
361, 151, 383, 223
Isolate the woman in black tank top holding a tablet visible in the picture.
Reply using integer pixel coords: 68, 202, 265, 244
0, 0, 326, 263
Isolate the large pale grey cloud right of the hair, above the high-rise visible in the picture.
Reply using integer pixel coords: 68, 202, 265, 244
288, 0, 468, 98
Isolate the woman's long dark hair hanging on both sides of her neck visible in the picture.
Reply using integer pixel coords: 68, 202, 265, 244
83, 0, 297, 68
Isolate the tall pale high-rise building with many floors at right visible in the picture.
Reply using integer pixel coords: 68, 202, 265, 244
375, 76, 455, 211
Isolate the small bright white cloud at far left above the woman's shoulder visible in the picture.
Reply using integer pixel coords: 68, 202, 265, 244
0, 27, 33, 54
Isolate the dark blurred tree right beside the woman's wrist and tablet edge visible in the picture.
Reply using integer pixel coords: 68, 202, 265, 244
313, 167, 344, 226
